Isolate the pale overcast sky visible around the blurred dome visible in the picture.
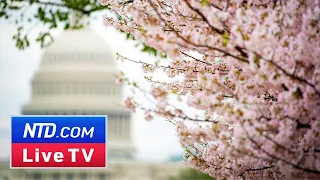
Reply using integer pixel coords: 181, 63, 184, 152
0, 12, 181, 161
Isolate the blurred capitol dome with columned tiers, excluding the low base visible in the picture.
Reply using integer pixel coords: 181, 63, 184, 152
22, 28, 134, 159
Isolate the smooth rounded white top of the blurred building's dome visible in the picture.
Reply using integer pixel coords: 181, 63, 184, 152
41, 28, 116, 71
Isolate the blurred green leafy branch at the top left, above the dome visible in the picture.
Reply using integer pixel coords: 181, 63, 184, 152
0, 0, 166, 58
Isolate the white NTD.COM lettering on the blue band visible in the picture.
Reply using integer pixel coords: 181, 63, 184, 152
23, 123, 94, 138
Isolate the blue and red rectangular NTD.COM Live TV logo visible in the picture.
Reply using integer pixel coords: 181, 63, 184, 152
11, 116, 107, 168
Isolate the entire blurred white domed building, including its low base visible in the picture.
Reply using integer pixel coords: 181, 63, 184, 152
0, 28, 184, 180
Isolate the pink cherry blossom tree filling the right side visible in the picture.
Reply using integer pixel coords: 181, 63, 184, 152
101, 0, 320, 179
